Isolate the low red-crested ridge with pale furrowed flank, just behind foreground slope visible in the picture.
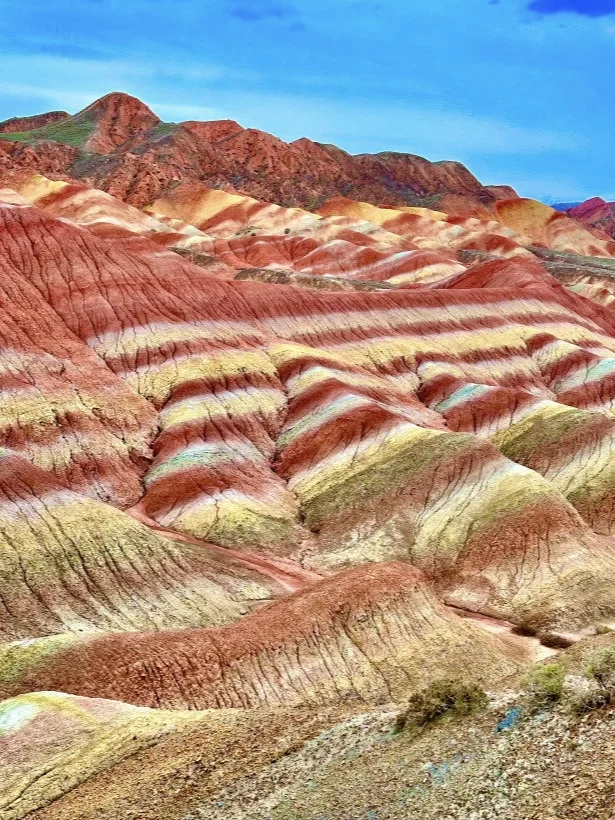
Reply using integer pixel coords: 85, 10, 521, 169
0, 563, 516, 709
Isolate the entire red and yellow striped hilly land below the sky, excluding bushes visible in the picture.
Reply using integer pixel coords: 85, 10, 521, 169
0, 94, 615, 820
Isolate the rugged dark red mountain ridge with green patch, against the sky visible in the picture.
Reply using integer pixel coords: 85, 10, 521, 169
0, 93, 510, 207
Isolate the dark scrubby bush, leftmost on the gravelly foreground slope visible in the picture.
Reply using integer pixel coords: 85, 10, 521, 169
395, 678, 489, 731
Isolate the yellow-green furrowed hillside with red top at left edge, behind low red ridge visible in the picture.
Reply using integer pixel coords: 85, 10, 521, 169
0, 442, 311, 641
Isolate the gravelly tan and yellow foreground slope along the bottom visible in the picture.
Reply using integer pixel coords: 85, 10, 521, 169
7, 640, 615, 820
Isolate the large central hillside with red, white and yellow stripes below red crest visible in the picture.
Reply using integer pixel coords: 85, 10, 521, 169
2, 197, 615, 624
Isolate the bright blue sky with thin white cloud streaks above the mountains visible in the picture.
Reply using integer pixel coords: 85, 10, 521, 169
0, 0, 615, 201
